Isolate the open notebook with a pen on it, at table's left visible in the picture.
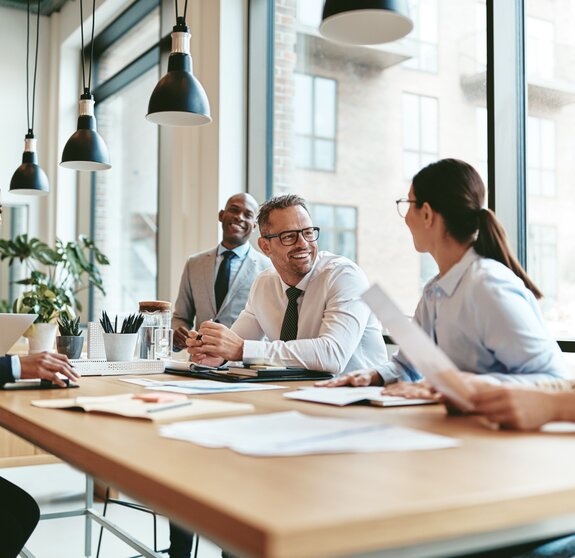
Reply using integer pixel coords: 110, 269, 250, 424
31, 393, 253, 422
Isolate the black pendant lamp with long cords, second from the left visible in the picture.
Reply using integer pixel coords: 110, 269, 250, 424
60, 0, 112, 171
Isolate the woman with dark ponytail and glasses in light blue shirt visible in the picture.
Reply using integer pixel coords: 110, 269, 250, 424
322, 159, 566, 396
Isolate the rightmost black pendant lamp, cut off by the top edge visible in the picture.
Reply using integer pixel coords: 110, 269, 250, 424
319, 0, 413, 45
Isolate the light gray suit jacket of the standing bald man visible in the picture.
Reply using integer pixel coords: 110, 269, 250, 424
172, 246, 271, 330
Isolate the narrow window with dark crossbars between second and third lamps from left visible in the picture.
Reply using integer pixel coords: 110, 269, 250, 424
92, 0, 160, 316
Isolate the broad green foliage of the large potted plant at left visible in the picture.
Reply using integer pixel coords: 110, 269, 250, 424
0, 234, 110, 323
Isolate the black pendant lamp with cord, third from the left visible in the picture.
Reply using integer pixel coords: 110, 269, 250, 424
146, 0, 212, 126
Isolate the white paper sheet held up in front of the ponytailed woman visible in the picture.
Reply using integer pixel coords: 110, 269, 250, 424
362, 285, 473, 411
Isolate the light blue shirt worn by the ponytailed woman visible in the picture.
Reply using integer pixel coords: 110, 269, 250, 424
379, 248, 567, 383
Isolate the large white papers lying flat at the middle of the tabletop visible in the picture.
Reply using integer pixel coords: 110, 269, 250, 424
160, 411, 460, 456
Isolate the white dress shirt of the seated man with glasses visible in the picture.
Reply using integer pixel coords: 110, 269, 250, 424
232, 252, 387, 374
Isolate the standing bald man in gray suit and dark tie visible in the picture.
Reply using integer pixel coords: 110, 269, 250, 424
172, 194, 271, 349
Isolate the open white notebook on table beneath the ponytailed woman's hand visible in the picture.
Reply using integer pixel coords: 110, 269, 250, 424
284, 386, 437, 407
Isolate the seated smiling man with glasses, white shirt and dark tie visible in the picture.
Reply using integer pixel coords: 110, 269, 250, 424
187, 194, 387, 374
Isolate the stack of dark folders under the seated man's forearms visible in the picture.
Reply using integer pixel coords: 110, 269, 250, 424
166, 360, 333, 382
